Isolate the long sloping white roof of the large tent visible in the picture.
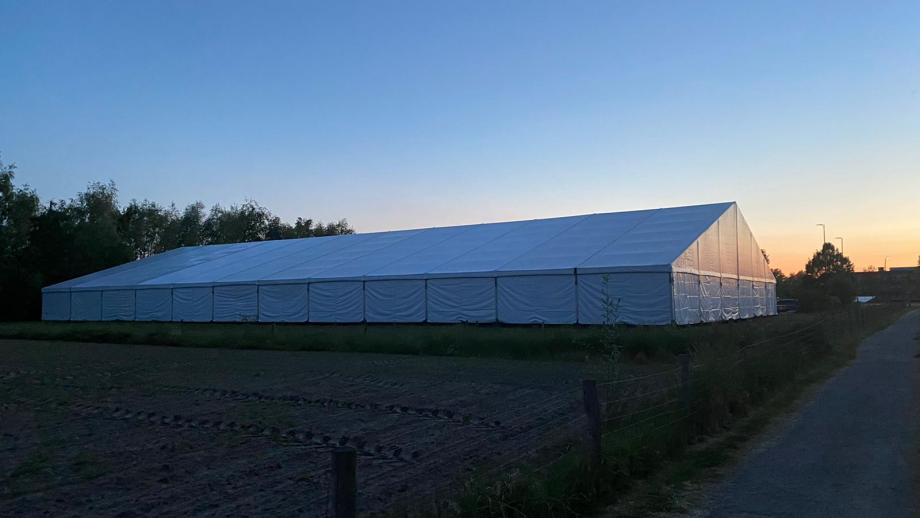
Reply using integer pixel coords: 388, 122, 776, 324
45, 202, 756, 291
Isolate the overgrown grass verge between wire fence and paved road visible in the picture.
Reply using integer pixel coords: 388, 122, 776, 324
456, 306, 903, 517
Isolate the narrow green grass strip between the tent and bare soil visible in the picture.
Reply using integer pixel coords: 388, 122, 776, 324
0, 314, 817, 361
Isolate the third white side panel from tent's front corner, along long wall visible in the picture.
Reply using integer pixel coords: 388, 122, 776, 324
428, 277, 496, 323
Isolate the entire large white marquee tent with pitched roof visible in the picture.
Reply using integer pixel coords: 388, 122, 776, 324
42, 203, 776, 325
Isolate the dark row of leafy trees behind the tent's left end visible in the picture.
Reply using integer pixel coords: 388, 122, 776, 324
0, 158, 354, 320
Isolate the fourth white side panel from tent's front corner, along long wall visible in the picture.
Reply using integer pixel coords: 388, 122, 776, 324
364, 280, 425, 323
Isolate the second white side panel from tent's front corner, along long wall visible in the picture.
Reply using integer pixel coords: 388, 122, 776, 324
497, 275, 577, 324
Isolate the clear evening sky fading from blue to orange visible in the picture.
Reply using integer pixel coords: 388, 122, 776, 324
0, 0, 920, 276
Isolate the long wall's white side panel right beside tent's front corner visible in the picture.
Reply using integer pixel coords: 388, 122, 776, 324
578, 272, 671, 325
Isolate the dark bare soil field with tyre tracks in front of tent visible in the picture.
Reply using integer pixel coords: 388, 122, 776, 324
0, 340, 654, 516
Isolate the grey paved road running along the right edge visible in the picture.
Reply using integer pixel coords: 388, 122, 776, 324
693, 311, 920, 518
